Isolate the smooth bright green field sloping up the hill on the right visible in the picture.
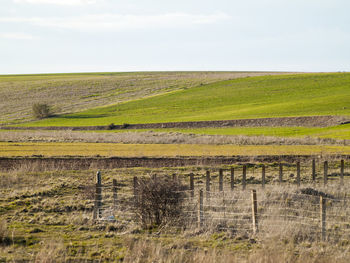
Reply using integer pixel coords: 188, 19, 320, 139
25, 73, 350, 126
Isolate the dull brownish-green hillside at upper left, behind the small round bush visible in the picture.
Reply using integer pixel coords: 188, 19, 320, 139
0, 72, 278, 124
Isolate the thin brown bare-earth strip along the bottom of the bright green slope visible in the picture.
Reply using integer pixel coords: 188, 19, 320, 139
0, 116, 350, 131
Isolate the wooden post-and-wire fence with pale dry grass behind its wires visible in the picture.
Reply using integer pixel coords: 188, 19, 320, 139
93, 161, 350, 242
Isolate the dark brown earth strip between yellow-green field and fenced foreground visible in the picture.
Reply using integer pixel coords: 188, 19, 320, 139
0, 155, 350, 171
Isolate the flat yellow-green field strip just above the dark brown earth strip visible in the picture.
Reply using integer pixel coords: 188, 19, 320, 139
0, 142, 350, 157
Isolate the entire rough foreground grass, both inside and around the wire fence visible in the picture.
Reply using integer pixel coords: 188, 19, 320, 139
0, 163, 350, 263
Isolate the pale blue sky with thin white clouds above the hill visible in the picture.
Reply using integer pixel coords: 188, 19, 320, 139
0, 0, 350, 74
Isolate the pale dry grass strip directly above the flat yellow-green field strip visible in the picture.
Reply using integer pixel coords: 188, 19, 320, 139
0, 131, 350, 145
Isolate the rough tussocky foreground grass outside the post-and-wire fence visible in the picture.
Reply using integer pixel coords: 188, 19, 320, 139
0, 167, 349, 263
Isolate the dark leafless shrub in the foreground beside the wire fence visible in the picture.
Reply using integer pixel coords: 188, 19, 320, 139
135, 178, 186, 227
